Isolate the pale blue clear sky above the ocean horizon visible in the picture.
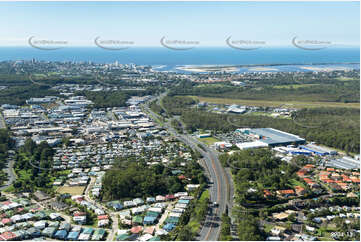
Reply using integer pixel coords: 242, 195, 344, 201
0, 2, 360, 46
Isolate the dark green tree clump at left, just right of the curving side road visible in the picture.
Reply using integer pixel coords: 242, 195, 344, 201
14, 139, 54, 191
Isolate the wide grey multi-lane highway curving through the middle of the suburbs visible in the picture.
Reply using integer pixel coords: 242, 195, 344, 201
143, 93, 233, 241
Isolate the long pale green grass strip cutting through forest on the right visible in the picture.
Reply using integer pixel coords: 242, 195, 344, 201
189, 96, 360, 109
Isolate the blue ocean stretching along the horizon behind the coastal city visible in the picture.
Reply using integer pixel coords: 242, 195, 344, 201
0, 47, 360, 71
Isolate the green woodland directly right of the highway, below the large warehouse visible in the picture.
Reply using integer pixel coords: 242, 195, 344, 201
220, 149, 298, 241
